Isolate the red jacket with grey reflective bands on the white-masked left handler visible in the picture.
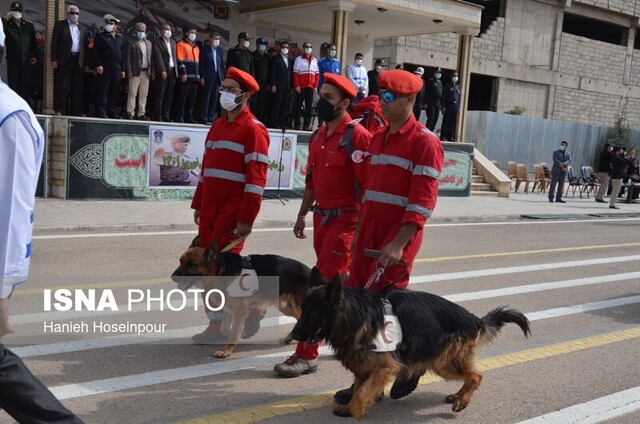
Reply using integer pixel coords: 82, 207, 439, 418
191, 107, 269, 225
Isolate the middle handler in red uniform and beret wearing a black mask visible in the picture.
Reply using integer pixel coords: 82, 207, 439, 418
274, 73, 371, 377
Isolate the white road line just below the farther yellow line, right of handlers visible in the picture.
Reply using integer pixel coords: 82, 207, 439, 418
409, 255, 640, 284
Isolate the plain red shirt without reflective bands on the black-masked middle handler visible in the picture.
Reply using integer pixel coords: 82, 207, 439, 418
306, 115, 371, 209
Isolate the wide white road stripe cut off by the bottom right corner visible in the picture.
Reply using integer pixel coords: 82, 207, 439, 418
518, 386, 640, 424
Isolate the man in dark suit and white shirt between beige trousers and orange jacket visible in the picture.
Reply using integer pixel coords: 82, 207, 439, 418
151, 24, 178, 122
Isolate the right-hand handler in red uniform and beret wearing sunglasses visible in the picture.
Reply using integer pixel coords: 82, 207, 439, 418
334, 69, 444, 403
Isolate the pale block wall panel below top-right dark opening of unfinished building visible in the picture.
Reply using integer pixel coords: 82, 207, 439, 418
558, 32, 627, 82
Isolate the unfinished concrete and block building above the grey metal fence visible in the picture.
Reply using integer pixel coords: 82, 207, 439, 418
374, 0, 640, 129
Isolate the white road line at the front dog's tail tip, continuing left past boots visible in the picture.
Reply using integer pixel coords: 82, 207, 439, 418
43, 296, 640, 399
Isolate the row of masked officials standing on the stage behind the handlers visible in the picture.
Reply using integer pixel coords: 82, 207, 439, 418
3, 2, 460, 134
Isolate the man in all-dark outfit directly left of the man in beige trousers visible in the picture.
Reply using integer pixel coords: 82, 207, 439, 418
93, 14, 124, 119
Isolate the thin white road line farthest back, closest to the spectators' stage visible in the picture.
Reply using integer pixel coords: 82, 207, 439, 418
32, 218, 640, 240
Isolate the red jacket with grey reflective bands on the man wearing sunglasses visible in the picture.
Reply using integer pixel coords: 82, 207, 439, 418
362, 115, 444, 230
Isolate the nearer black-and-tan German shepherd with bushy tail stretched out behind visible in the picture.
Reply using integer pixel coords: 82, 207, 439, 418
292, 273, 531, 419
